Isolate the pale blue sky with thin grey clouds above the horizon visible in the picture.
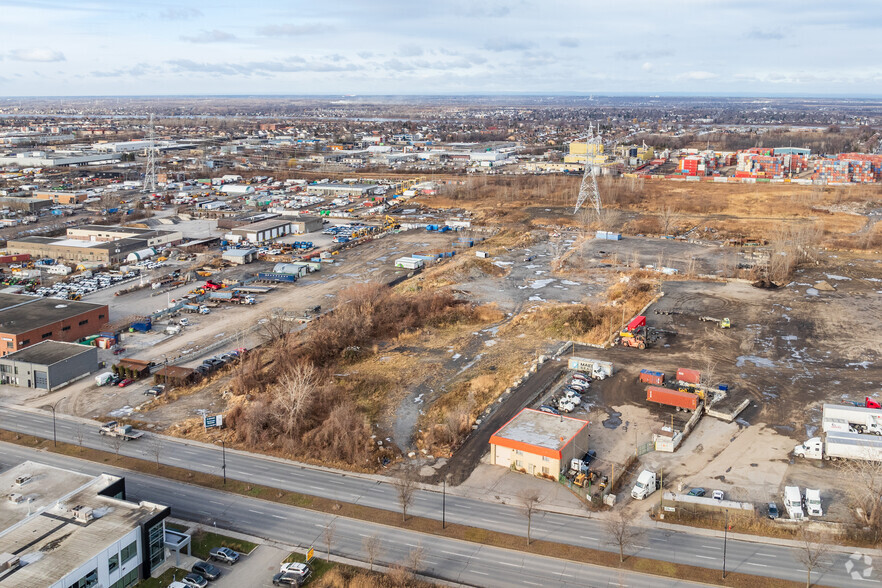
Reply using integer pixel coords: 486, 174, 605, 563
0, 0, 882, 96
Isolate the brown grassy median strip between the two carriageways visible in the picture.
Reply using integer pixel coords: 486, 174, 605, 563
0, 430, 832, 588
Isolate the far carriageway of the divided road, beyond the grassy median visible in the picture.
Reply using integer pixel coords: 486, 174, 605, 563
0, 406, 868, 587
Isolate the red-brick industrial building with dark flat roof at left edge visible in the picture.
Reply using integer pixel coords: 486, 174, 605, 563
0, 294, 110, 355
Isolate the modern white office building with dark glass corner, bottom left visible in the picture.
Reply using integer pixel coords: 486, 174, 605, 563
0, 461, 170, 588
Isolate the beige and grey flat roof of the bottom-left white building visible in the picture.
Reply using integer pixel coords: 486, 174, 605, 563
0, 461, 166, 588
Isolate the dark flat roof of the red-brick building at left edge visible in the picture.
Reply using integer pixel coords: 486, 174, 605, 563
0, 294, 107, 334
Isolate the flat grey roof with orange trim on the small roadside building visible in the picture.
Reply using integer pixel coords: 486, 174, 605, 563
490, 408, 588, 458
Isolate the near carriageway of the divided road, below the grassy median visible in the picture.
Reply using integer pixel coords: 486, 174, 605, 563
0, 443, 698, 588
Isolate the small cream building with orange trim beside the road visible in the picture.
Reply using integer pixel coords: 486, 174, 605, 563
490, 408, 588, 480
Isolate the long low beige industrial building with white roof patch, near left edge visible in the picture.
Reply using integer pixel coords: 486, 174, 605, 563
6, 237, 154, 264
